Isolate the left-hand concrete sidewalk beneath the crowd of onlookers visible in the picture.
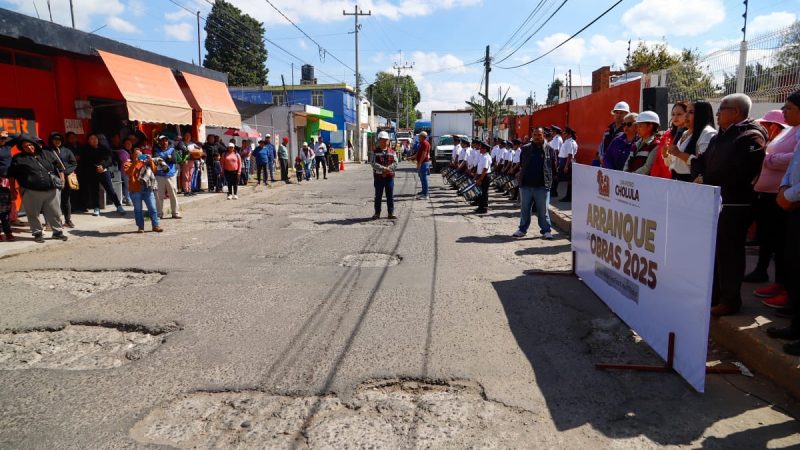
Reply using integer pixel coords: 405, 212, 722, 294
0, 177, 297, 259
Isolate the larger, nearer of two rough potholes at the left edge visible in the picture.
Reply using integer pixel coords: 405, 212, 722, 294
0, 323, 180, 370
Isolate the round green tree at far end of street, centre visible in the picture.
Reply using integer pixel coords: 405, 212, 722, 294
367, 72, 421, 128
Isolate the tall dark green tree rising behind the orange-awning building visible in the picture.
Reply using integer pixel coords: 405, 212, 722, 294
203, 0, 269, 86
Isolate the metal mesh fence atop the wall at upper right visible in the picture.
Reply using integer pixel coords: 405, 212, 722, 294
645, 22, 800, 103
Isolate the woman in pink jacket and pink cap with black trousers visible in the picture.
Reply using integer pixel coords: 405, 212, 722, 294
744, 110, 797, 308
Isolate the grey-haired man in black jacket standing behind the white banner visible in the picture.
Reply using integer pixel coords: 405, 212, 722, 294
691, 94, 767, 316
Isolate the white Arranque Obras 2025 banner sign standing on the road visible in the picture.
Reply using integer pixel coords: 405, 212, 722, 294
572, 164, 721, 392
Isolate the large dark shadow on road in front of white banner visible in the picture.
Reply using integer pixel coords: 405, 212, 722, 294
492, 275, 798, 448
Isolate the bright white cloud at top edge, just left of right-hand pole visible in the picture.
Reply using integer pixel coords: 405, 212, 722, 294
622, 0, 725, 37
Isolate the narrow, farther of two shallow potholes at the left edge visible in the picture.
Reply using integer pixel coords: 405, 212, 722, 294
0, 269, 166, 298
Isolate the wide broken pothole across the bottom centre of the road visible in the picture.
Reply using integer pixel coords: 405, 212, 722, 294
130, 380, 541, 449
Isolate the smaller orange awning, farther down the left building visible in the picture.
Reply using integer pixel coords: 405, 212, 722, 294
183, 72, 242, 128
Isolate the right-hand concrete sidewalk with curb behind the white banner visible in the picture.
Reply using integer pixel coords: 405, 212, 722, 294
550, 188, 800, 399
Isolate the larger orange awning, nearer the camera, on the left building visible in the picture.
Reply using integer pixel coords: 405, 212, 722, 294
97, 50, 192, 125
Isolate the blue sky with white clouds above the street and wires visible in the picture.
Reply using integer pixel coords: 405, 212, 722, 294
0, 0, 800, 114
